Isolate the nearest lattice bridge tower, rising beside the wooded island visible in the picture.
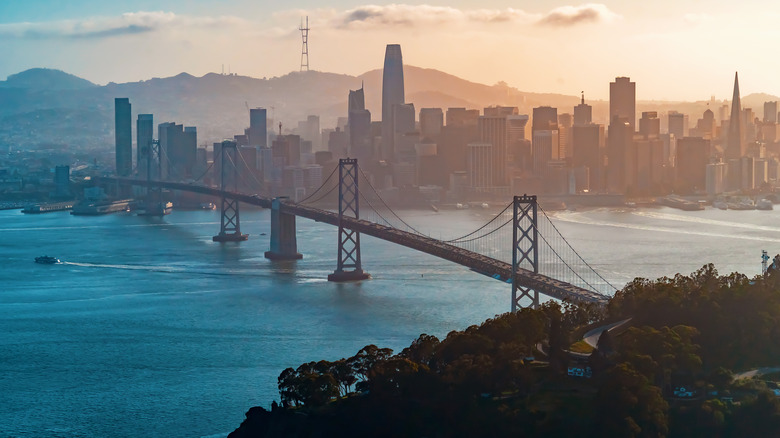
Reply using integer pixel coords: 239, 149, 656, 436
512, 195, 539, 312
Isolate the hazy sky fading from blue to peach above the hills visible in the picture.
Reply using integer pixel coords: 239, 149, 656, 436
0, 0, 780, 100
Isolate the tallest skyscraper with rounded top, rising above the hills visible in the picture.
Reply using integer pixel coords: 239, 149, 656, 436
382, 44, 405, 161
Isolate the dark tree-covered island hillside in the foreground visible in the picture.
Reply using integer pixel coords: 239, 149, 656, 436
229, 265, 780, 438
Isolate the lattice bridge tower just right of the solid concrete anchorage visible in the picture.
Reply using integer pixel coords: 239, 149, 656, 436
328, 158, 371, 282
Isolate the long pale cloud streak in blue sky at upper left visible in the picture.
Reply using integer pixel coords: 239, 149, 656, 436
0, 11, 244, 39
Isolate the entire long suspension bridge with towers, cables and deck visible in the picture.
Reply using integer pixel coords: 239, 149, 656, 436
93, 141, 616, 311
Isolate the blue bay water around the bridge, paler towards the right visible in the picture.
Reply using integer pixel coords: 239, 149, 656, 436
0, 208, 780, 437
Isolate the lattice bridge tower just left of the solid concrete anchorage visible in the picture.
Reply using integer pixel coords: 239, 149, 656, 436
212, 140, 249, 242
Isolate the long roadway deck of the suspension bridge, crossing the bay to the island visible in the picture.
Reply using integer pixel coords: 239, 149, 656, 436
92, 177, 608, 304
